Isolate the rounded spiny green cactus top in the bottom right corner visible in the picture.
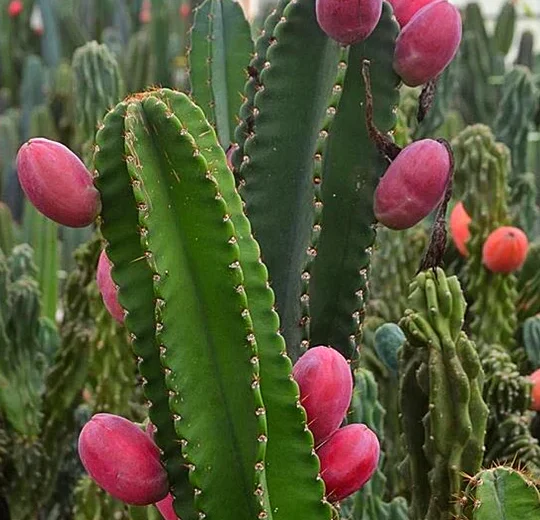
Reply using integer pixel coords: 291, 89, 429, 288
461, 466, 540, 520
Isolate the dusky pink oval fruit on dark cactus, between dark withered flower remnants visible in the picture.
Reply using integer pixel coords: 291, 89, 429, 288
374, 139, 450, 229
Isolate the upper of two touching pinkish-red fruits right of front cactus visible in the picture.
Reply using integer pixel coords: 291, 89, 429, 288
293, 347, 353, 446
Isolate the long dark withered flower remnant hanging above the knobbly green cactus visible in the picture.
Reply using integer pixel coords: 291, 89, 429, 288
417, 139, 454, 274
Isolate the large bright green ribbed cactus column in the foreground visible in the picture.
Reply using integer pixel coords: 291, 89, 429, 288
95, 90, 332, 520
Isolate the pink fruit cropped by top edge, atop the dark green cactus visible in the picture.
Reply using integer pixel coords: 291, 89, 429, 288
315, 0, 382, 45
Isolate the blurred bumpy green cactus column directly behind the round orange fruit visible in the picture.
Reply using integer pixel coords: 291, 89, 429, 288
453, 125, 517, 350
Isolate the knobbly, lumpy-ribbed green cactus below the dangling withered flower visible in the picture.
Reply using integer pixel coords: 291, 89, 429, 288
400, 268, 488, 520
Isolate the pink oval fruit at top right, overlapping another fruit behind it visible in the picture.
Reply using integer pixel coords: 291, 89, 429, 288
394, 0, 462, 87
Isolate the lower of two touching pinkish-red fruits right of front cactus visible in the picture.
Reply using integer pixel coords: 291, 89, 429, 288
317, 424, 380, 502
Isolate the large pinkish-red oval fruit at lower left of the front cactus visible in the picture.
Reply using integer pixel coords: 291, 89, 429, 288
79, 413, 169, 506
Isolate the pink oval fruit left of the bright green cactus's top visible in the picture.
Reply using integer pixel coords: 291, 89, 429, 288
17, 138, 101, 227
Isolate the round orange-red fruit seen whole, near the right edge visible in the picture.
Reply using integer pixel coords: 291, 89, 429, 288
482, 226, 529, 273
